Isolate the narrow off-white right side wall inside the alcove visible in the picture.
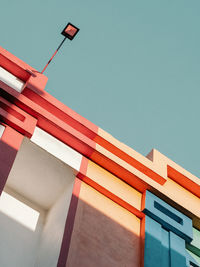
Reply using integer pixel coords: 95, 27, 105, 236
36, 179, 74, 267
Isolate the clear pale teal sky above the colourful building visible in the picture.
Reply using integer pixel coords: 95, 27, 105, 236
0, 0, 200, 177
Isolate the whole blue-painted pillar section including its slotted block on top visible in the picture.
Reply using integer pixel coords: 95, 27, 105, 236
144, 191, 200, 267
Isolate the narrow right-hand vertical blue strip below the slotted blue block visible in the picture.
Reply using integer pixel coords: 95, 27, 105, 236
169, 232, 186, 267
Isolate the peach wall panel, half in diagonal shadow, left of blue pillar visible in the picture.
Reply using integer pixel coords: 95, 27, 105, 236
66, 183, 140, 267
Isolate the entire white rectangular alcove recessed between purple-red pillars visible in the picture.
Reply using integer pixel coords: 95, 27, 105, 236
0, 138, 76, 267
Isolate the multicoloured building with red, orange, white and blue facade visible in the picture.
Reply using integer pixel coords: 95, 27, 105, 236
0, 48, 200, 267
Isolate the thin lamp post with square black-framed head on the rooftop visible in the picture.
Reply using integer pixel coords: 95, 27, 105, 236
41, 23, 79, 73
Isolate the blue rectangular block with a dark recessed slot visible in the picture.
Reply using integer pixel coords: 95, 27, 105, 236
143, 191, 193, 242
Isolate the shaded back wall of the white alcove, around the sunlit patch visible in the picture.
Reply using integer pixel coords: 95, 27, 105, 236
0, 188, 45, 267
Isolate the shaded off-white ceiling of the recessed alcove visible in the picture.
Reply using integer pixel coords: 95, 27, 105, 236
7, 138, 74, 210
